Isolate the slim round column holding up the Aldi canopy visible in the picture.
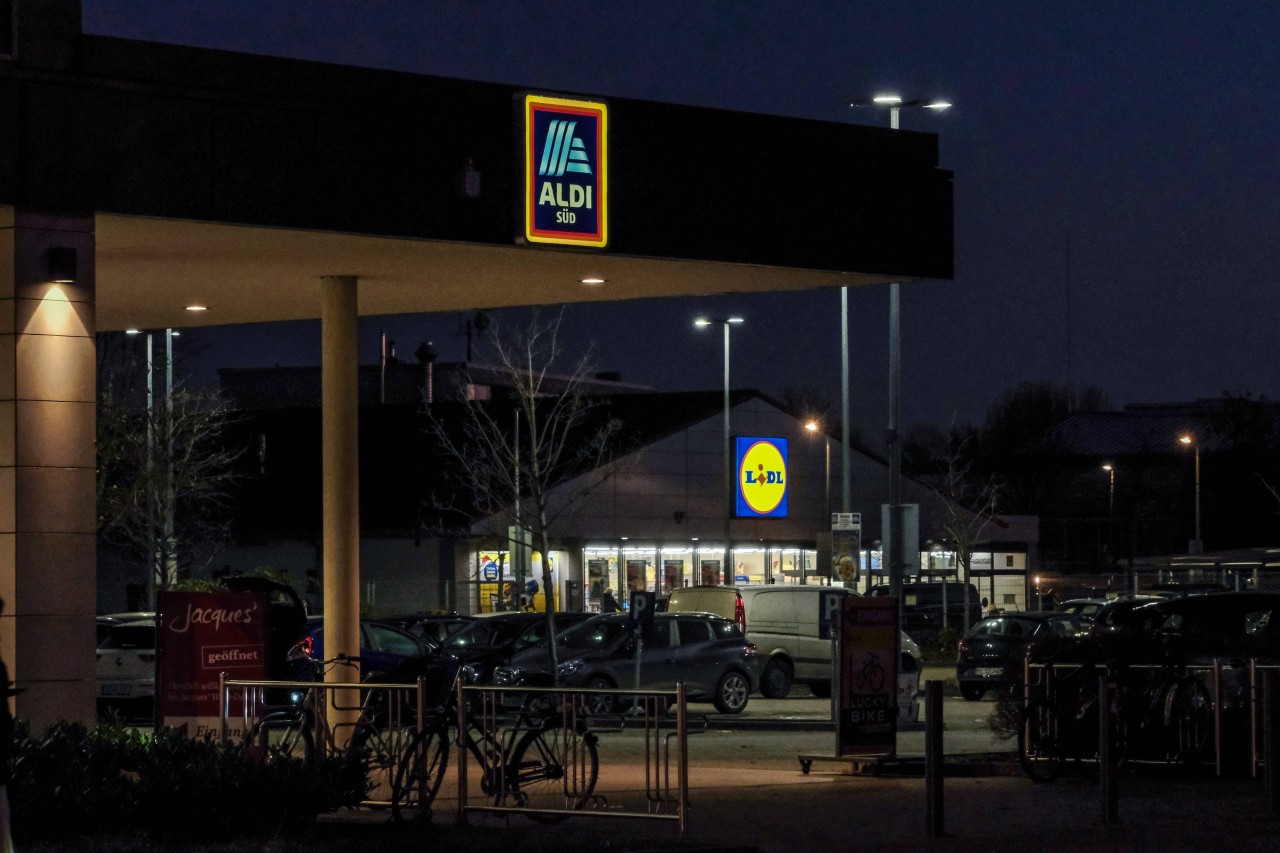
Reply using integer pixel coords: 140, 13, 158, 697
320, 275, 360, 666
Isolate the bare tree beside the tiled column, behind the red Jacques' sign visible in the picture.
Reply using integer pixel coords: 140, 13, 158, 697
97, 383, 239, 601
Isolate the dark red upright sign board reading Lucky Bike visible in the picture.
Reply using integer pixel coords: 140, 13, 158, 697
836, 596, 900, 756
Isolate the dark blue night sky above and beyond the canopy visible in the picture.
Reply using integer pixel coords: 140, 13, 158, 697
83, 0, 1280, 437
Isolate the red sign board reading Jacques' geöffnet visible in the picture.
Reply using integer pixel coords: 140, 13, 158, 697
156, 592, 268, 736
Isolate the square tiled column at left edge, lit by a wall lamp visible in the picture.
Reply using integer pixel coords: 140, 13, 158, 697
0, 207, 97, 731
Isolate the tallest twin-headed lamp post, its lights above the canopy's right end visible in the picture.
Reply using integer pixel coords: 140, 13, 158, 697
845, 93, 951, 601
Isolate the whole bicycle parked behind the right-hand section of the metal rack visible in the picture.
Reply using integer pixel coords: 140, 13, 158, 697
392, 666, 600, 824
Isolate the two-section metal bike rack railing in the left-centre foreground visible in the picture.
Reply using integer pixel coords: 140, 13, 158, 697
219, 672, 705, 839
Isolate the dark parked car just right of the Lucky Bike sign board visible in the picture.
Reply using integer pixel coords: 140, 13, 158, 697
956, 611, 1083, 701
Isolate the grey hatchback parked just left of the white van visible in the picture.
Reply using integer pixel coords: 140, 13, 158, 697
545, 612, 756, 713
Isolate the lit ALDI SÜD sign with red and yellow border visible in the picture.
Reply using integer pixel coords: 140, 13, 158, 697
524, 95, 609, 248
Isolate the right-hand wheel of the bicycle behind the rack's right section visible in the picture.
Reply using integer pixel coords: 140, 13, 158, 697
497, 726, 600, 824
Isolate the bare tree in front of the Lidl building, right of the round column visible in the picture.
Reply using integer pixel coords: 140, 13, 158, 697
433, 310, 620, 672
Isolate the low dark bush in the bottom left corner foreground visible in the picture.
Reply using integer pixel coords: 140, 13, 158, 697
9, 722, 366, 841
